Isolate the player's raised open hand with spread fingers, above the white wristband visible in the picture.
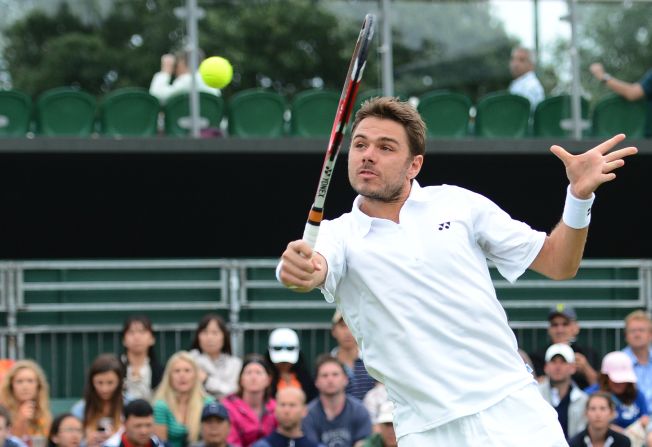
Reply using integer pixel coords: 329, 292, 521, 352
550, 134, 638, 199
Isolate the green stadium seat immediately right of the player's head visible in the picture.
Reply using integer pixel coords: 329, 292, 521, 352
417, 91, 471, 138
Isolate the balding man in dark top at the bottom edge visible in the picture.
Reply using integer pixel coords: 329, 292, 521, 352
253, 387, 321, 447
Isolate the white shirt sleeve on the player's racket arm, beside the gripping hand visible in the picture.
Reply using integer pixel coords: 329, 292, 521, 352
315, 220, 346, 303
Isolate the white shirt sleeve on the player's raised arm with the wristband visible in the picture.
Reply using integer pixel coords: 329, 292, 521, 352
474, 194, 546, 282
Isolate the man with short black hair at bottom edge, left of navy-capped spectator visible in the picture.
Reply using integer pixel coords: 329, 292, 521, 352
104, 399, 162, 447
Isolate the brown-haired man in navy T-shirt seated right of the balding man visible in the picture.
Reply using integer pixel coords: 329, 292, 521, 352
303, 355, 371, 447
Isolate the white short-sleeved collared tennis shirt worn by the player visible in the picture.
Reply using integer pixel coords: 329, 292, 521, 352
315, 181, 545, 437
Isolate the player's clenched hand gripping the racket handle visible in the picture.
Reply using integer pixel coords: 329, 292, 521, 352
278, 240, 327, 292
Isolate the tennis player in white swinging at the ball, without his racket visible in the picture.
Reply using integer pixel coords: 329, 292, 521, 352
277, 98, 637, 447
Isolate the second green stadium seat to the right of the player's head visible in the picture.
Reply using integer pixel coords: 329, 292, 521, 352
475, 92, 530, 138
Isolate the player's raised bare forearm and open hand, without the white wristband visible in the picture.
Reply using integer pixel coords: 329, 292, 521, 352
530, 134, 638, 279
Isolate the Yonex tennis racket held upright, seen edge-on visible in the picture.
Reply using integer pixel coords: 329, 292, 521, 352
302, 14, 376, 247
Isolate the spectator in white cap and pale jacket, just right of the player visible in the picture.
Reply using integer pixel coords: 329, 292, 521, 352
539, 343, 588, 439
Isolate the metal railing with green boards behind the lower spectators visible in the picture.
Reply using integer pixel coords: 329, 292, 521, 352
0, 259, 652, 396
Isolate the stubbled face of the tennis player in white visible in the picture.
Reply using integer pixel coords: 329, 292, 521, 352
349, 117, 423, 203
